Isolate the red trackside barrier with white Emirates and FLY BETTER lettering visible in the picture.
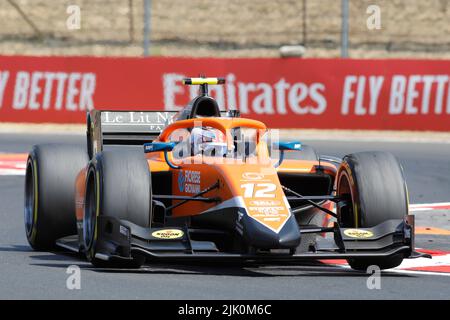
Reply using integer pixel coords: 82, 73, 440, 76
0, 56, 450, 131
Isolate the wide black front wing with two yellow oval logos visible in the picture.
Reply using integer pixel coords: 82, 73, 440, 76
57, 215, 424, 264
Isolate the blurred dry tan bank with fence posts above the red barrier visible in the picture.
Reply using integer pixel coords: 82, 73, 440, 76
0, 0, 450, 57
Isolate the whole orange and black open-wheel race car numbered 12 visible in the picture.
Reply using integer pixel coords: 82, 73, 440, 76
25, 77, 423, 270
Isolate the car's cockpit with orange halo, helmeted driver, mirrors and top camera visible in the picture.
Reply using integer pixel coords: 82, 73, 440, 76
144, 77, 301, 168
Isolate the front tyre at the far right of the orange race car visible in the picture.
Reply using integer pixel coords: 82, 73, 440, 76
336, 152, 408, 271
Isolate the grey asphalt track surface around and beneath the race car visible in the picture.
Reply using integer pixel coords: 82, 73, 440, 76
0, 134, 450, 300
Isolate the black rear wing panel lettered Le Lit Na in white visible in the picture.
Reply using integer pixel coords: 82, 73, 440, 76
87, 110, 177, 156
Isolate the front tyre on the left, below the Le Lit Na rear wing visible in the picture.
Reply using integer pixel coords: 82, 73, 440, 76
83, 150, 152, 268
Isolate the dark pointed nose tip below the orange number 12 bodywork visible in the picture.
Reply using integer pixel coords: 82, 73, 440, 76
243, 215, 301, 249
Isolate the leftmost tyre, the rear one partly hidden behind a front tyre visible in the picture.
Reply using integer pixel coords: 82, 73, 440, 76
24, 144, 88, 250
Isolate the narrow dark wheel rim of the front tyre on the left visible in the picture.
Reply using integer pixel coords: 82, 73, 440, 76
83, 171, 97, 251
